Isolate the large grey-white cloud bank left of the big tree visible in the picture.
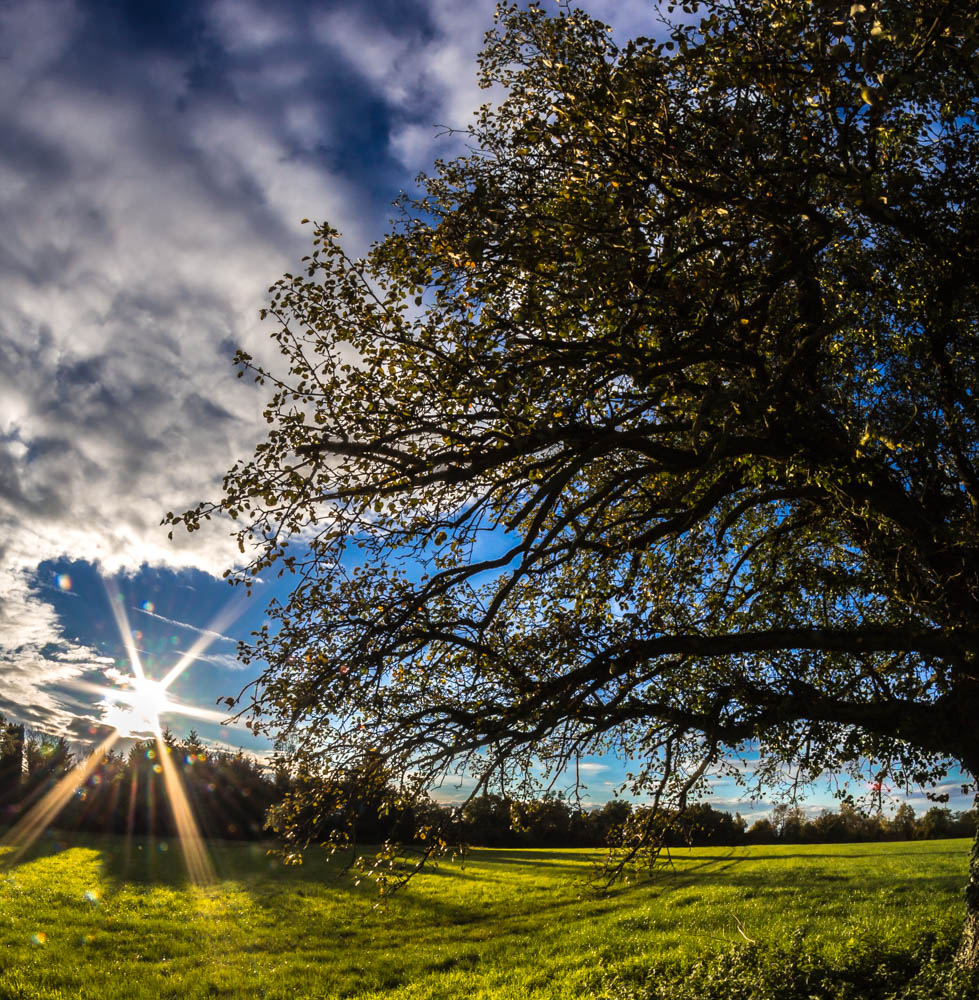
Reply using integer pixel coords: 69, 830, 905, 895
0, 0, 382, 731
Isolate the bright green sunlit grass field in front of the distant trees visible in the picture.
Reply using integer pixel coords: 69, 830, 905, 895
0, 835, 969, 1000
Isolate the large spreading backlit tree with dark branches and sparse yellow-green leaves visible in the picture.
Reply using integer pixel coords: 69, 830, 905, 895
168, 0, 979, 962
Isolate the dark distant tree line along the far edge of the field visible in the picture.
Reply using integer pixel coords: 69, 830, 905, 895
0, 716, 979, 847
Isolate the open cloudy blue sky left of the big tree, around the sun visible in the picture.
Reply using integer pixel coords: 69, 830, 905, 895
0, 0, 972, 820
